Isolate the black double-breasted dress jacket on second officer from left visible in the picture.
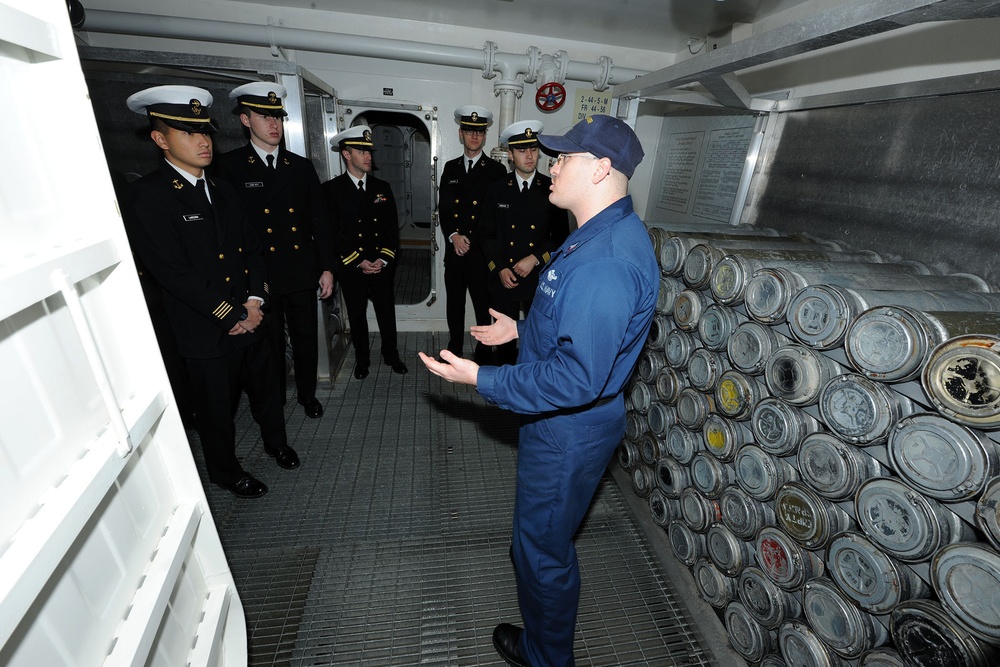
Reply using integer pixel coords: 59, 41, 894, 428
212, 144, 334, 294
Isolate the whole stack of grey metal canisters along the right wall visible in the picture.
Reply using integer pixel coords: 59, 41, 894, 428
618, 226, 1000, 667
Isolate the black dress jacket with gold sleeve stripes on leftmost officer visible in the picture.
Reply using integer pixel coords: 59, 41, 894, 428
124, 161, 267, 359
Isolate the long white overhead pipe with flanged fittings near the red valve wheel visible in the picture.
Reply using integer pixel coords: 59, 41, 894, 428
83, 10, 647, 134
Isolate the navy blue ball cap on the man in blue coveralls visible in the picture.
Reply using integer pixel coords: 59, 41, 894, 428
538, 115, 645, 178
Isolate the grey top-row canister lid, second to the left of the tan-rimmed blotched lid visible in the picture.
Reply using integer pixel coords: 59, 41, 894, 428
786, 285, 864, 350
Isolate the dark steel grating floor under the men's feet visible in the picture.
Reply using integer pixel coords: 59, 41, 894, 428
189, 333, 713, 667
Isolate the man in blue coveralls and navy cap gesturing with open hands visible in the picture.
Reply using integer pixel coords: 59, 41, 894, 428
420, 116, 659, 667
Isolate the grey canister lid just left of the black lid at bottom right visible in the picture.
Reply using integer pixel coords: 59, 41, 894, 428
802, 577, 889, 658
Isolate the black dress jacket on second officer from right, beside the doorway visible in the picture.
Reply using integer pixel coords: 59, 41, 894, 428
438, 154, 507, 268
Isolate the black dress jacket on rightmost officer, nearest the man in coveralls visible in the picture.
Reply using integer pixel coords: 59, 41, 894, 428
482, 172, 569, 301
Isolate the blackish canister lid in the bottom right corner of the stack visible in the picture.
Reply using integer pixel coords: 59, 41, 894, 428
889, 600, 998, 667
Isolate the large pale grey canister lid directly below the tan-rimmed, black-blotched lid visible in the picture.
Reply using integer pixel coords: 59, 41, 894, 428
888, 413, 1000, 501
